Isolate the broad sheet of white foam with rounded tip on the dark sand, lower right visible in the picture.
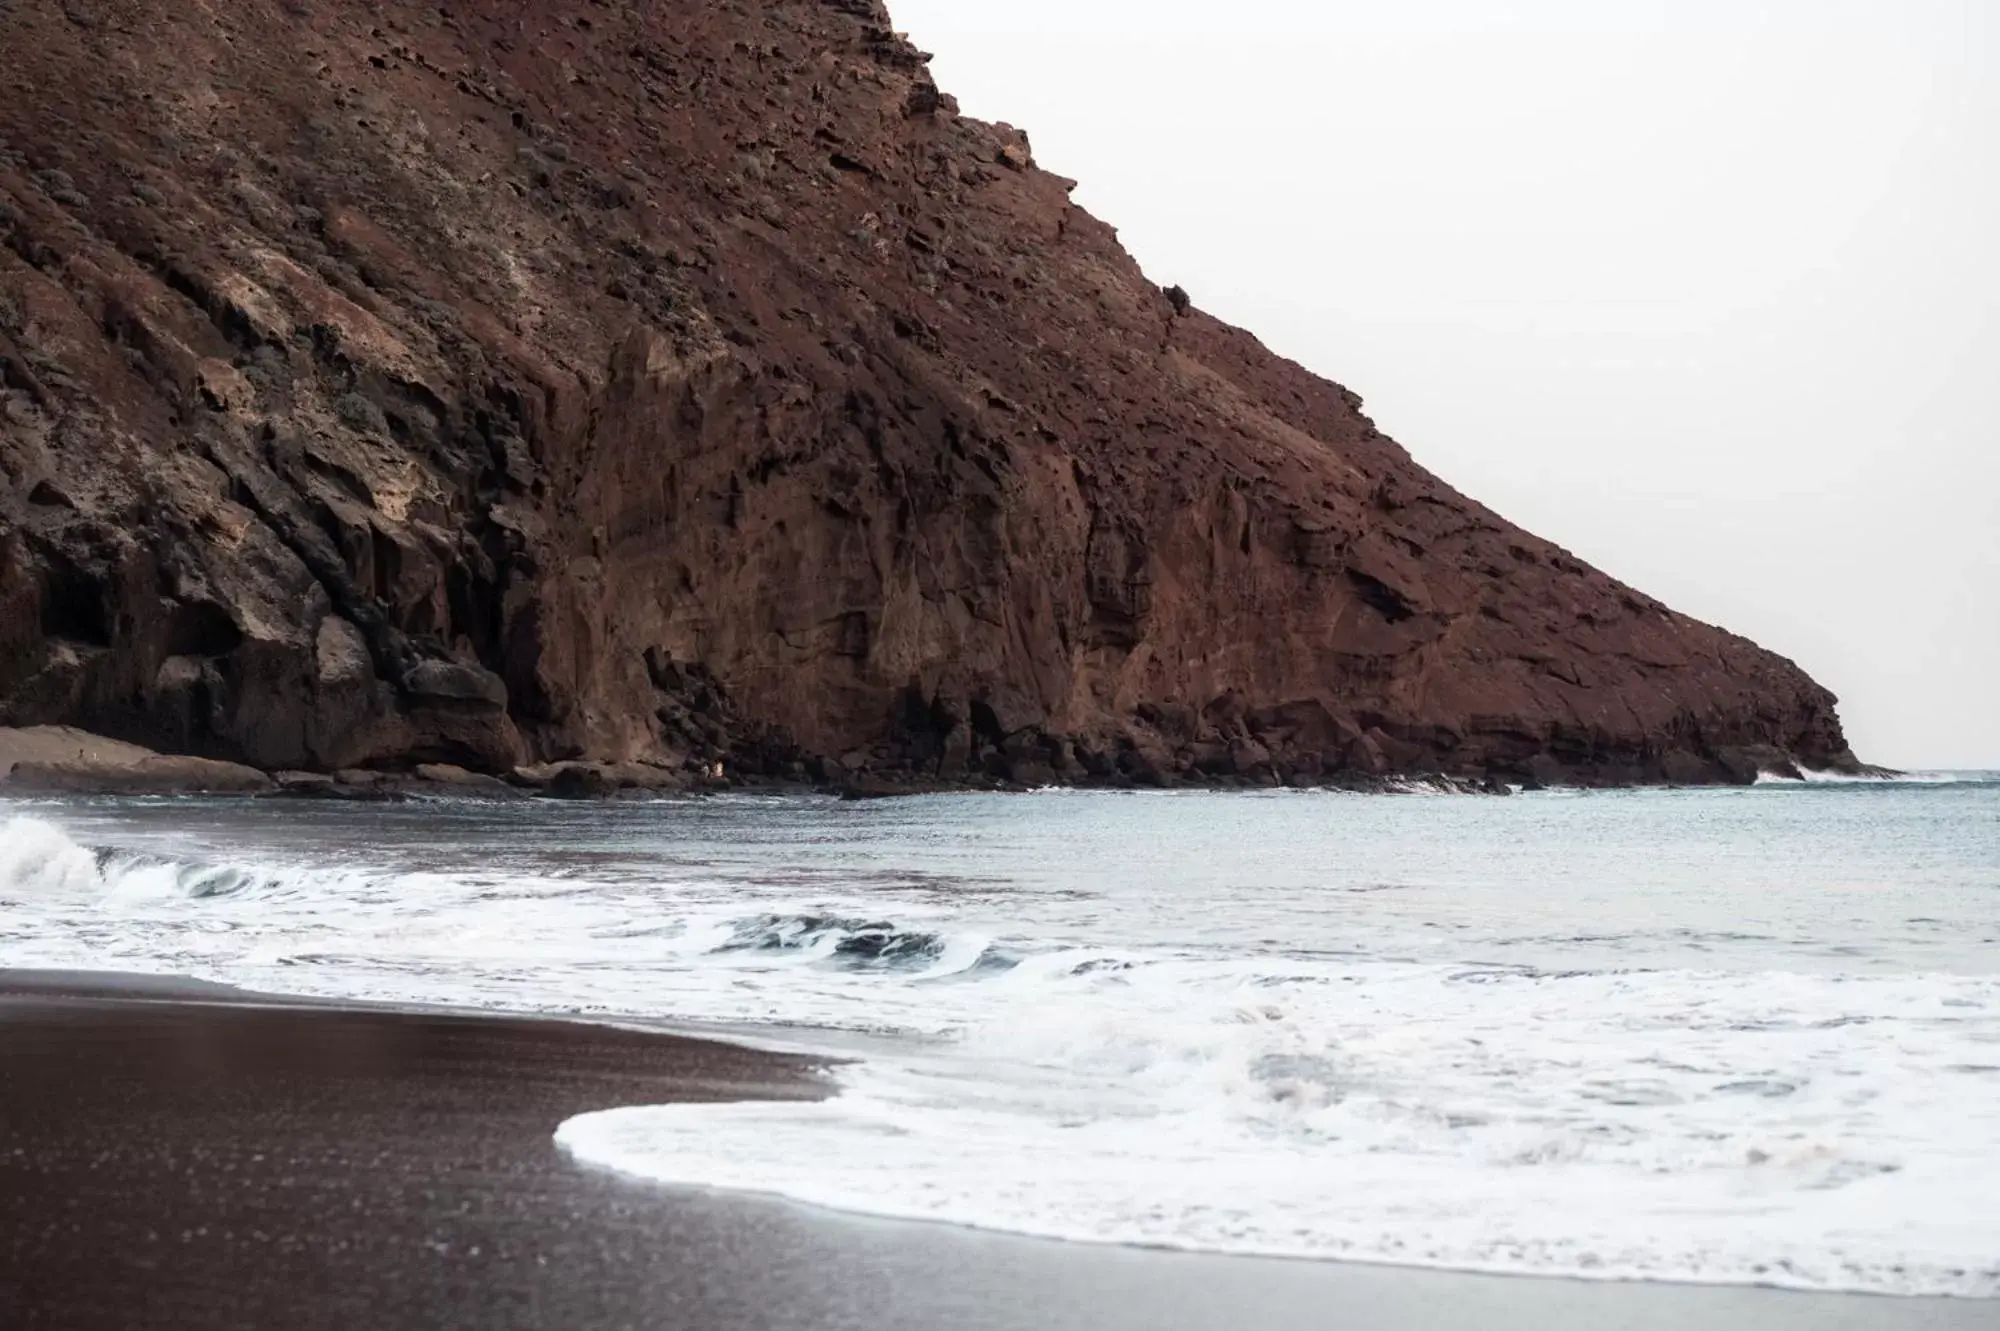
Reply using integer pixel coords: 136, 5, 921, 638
556, 957, 2000, 1297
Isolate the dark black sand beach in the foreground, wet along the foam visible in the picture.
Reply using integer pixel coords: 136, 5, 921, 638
0, 971, 2000, 1331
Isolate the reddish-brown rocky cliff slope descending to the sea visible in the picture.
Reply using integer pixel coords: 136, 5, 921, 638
0, 0, 1852, 781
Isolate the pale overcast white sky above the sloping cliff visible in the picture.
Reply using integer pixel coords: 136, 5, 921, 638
890, 0, 2000, 767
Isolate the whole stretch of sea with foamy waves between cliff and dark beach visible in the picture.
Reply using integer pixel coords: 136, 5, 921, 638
0, 777, 2000, 1297
